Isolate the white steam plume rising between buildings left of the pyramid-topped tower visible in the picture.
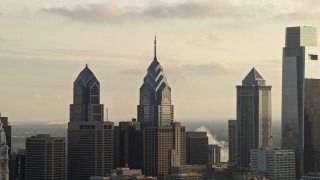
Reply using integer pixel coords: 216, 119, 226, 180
195, 126, 229, 162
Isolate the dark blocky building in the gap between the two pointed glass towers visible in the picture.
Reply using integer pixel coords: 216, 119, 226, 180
117, 119, 143, 169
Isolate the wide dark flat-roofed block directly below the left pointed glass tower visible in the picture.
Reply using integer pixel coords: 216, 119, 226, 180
68, 121, 114, 180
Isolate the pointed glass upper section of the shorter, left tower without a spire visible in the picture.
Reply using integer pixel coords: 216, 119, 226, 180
70, 64, 103, 122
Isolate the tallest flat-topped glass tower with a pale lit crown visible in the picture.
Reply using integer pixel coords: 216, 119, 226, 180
282, 26, 320, 178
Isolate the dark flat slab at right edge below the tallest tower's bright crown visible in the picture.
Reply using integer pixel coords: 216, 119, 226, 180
304, 79, 320, 172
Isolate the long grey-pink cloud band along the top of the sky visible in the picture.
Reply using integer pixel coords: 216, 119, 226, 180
39, 0, 254, 22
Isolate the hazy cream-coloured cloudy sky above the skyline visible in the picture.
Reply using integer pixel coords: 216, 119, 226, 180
0, 0, 320, 123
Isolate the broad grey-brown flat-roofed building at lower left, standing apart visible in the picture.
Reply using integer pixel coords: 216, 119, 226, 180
25, 134, 66, 180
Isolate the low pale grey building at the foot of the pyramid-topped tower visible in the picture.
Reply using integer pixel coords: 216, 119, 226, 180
250, 147, 296, 180
